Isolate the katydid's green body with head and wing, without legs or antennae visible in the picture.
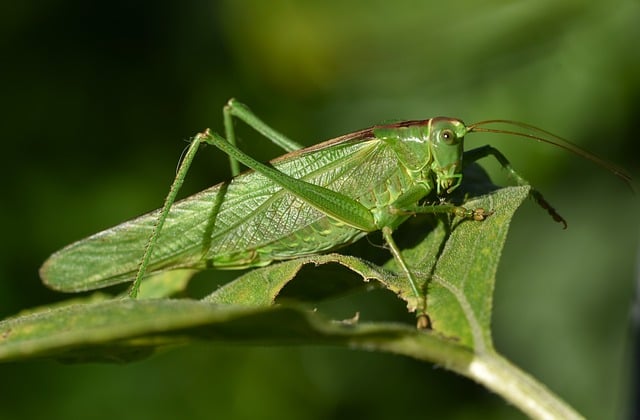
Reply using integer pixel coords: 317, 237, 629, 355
41, 119, 462, 291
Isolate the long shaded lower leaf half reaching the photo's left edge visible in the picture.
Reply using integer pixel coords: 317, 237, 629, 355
0, 299, 457, 361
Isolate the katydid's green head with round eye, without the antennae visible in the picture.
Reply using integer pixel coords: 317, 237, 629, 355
429, 117, 467, 194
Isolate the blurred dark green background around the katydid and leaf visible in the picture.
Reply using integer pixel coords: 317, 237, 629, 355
0, 0, 640, 419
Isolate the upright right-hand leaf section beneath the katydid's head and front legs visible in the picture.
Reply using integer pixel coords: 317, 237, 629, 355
418, 187, 529, 351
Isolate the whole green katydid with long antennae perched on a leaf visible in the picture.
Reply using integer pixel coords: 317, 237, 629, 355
40, 99, 630, 327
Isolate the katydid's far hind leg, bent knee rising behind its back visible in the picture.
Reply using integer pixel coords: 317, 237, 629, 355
222, 99, 303, 176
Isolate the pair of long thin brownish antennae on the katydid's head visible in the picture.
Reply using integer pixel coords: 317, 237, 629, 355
466, 120, 633, 189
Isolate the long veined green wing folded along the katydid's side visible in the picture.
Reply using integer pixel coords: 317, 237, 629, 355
40, 138, 401, 291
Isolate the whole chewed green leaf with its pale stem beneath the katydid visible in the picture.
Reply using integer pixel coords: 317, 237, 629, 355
0, 187, 579, 418
